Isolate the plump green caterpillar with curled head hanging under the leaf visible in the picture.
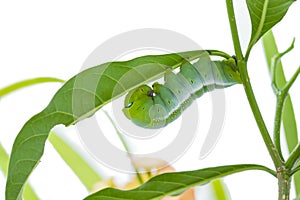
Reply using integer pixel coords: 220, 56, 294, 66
123, 53, 241, 128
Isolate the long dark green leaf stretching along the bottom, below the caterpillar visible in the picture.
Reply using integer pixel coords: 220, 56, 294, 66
85, 165, 276, 200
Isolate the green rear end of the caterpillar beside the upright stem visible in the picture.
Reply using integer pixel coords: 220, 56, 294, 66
223, 58, 242, 83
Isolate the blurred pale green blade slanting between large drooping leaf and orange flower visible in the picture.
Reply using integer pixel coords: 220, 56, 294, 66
49, 132, 102, 191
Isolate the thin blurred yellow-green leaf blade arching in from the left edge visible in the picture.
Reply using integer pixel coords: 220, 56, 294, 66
0, 77, 64, 97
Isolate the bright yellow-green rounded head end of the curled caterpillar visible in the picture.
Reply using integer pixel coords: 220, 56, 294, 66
123, 85, 153, 127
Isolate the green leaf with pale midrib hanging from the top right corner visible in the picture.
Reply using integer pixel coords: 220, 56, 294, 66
246, 0, 295, 58
